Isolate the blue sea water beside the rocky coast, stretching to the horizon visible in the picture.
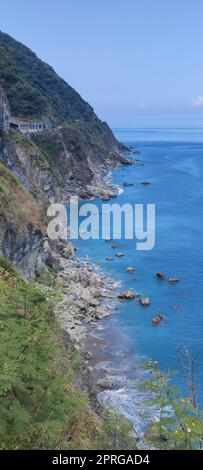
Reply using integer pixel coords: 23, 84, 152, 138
73, 127, 203, 428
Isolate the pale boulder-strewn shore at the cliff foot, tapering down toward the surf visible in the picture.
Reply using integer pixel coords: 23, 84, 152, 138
53, 246, 149, 445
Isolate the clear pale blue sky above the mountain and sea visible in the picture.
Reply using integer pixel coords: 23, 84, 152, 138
0, 0, 203, 126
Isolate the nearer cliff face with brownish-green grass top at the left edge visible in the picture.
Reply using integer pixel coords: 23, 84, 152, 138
0, 163, 47, 278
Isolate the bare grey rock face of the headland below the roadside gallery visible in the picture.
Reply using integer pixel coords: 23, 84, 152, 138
0, 124, 130, 205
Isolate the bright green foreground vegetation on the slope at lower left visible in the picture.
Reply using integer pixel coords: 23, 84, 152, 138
0, 257, 136, 450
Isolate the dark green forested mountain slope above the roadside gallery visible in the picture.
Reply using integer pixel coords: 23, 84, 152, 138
0, 32, 97, 122
